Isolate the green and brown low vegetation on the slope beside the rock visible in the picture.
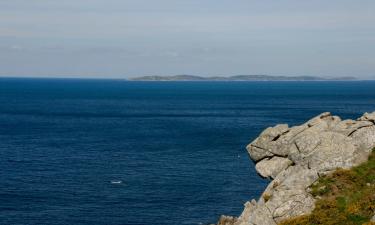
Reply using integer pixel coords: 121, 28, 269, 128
280, 148, 375, 225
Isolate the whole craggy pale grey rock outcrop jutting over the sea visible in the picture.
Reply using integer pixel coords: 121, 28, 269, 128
217, 112, 375, 225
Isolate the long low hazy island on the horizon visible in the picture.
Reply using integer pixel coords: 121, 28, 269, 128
128, 75, 357, 81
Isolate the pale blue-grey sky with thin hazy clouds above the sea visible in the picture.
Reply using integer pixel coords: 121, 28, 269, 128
0, 0, 375, 79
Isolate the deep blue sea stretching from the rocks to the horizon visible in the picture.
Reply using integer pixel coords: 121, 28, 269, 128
0, 79, 375, 225
